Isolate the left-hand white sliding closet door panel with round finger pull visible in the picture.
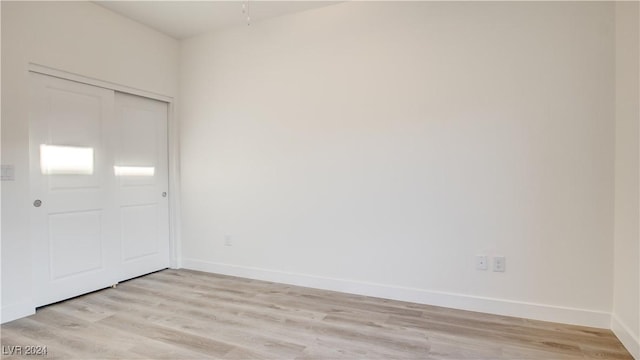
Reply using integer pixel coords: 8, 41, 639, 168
29, 73, 120, 306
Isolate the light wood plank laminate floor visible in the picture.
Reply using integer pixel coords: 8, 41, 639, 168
1, 270, 632, 359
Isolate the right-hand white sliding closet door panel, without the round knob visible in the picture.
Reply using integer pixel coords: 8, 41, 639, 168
111, 93, 169, 279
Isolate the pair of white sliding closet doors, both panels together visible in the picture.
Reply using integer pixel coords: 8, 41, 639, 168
29, 73, 169, 306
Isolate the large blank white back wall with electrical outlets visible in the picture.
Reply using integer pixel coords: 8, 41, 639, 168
180, 2, 615, 327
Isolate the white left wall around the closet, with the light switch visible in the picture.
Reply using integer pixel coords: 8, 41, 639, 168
1, 1, 178, 322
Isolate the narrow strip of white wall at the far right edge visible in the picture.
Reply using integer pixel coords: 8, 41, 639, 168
611, 2, 640, 359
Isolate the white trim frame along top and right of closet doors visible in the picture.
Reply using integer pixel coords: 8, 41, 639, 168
28, 63, 182, 269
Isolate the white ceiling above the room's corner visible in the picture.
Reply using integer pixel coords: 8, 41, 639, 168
94, 0, 336, 39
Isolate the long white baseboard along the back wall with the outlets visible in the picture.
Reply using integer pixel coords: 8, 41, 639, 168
182, 259, 611, 329
